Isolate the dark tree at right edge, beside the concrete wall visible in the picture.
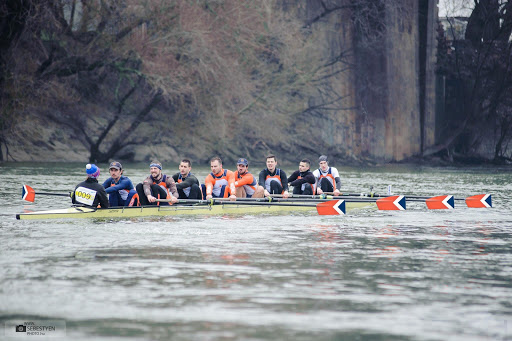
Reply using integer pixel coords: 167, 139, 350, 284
431, 0, 512, 162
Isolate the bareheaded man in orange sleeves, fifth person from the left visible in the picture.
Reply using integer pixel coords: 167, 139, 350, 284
202, 156, 236, 200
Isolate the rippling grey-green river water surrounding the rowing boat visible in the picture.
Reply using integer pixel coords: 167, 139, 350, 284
0, 164, 512, 341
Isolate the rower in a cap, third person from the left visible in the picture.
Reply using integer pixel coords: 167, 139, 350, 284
136, 160, 178, 206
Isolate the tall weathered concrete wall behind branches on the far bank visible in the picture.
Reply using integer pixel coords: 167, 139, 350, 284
297, 0, 437, 162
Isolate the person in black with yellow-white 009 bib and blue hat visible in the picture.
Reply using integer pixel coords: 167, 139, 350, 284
71, 164, 108, 208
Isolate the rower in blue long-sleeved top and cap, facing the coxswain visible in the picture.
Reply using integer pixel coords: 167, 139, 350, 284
103, 161, 137, 207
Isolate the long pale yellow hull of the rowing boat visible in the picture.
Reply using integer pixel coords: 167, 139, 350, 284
16, 202, 376, 220
